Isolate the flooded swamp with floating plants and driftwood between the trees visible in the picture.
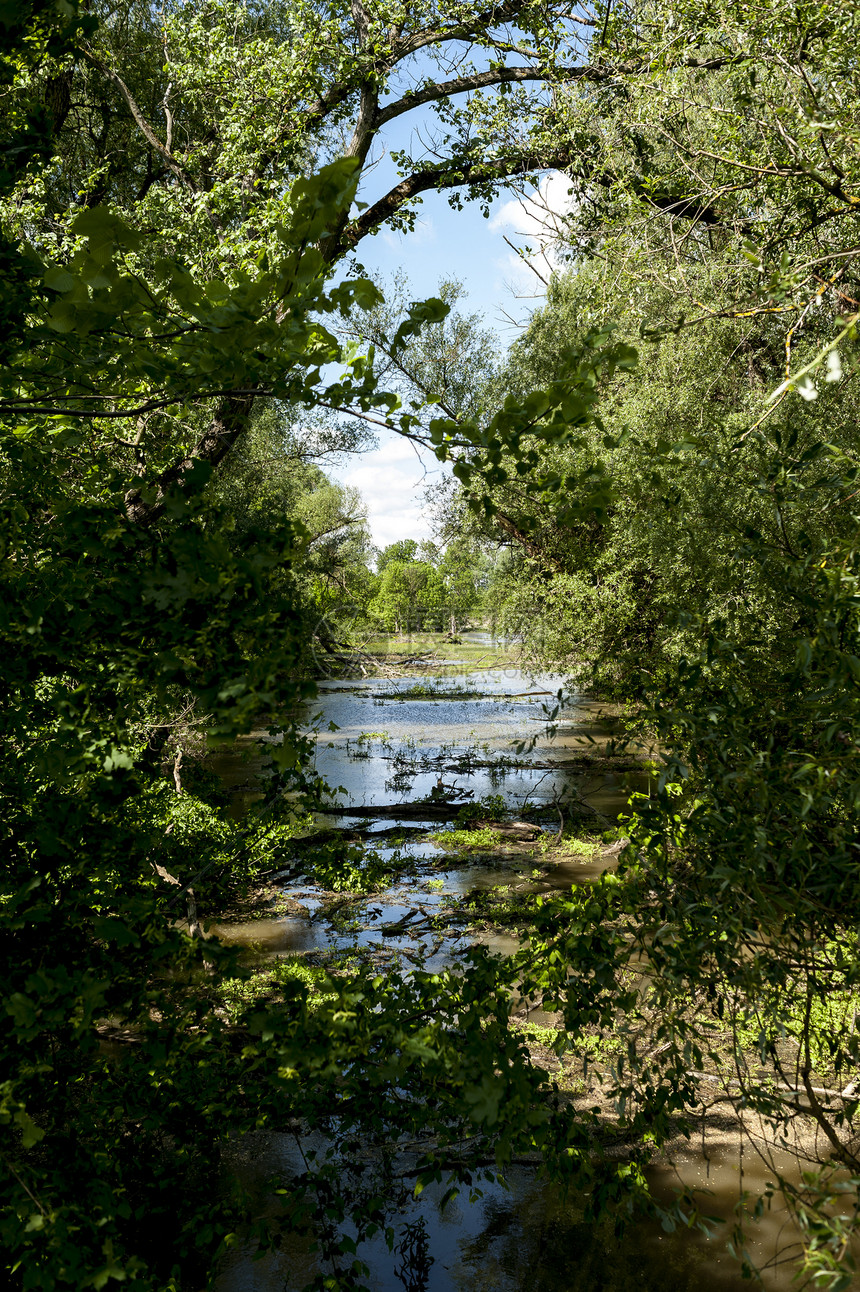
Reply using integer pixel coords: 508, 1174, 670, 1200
198, 630, 852, 1292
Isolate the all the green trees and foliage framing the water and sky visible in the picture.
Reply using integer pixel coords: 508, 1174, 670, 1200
0, 0, 860, 1292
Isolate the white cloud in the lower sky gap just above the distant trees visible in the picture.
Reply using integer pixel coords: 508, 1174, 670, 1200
337, 435, 440, 548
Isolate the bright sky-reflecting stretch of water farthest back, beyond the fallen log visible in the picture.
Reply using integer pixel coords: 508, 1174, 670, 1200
213, 668, 648, 819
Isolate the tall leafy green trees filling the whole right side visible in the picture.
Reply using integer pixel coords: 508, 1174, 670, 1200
428, 4, 860, 1288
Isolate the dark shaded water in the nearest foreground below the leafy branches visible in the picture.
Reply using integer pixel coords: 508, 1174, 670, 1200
216, 1136, 805, 1292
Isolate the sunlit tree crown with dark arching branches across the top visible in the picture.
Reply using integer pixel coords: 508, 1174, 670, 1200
5, 0, 759, 498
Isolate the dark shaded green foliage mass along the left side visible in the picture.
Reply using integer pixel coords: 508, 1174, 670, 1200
0, 22, 542, 1292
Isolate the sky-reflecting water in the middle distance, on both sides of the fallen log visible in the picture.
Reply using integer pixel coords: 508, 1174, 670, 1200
214, 668, 632, 969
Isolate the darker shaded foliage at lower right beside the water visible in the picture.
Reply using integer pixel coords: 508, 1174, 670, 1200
498, 369, 860, 1284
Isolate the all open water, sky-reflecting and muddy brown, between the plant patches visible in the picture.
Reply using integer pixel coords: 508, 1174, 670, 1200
207, 668, 852, 1292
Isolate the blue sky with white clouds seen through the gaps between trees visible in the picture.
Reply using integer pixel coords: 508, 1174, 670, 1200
331, 109, 567, 547
